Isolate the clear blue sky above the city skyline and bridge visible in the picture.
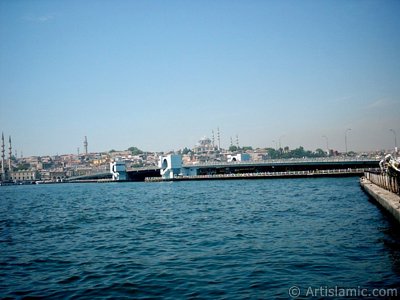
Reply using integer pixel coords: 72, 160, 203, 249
0, 0, 400, 155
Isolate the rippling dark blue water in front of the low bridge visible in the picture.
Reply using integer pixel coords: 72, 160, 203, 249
0, 177, 400, 299
